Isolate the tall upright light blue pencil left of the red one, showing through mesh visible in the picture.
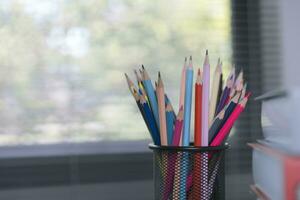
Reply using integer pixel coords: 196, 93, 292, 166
180, 56, 194, 199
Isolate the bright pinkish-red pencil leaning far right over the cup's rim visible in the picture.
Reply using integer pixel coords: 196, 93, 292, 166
211, 97, 248, 146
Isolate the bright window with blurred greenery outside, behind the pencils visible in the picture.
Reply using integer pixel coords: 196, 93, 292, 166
0, 0, 232, 146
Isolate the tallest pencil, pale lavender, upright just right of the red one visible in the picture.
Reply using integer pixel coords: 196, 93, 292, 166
201, 50, 210, 146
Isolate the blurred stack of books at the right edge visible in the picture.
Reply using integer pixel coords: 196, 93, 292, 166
249, 90, 300, 200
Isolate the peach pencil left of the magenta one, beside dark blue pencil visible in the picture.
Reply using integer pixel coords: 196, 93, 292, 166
156, 72, 168, 145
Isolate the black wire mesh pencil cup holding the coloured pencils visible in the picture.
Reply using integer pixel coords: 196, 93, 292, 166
149, 144, 229, 200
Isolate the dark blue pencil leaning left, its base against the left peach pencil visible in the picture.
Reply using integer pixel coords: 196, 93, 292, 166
139, 96, 160, 145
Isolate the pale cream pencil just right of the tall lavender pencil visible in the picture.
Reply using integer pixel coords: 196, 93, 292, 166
209, 58, 222, 124
